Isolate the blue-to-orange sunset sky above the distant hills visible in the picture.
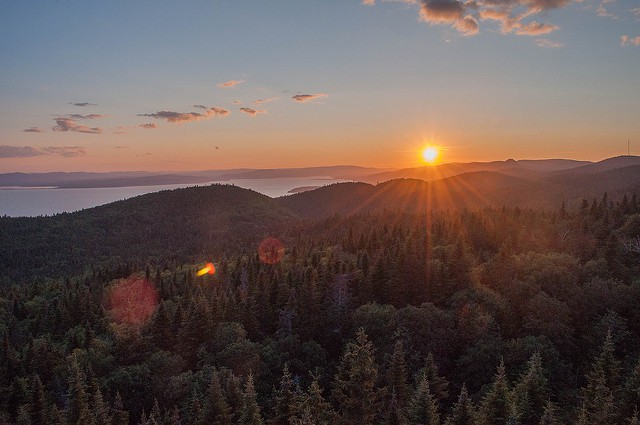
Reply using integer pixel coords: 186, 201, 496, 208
0, 0, 640, 173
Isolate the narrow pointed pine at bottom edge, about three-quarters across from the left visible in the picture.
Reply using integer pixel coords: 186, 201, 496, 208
478, 360, 515, 425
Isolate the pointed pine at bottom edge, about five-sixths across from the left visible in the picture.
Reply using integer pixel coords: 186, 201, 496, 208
513, 353, 549, 425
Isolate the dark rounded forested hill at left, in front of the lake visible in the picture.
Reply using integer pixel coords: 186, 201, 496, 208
0, 185, 296, 282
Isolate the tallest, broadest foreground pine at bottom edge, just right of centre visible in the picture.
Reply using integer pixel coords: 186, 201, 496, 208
332, 329, 379, 424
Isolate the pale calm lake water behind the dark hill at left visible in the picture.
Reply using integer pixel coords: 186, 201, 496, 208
0, 177, 346, 217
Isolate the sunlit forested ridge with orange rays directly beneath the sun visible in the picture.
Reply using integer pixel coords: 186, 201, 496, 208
277, 162, 640, 219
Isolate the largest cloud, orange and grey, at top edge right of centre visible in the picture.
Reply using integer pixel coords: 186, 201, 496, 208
363, 0, 568, 36
